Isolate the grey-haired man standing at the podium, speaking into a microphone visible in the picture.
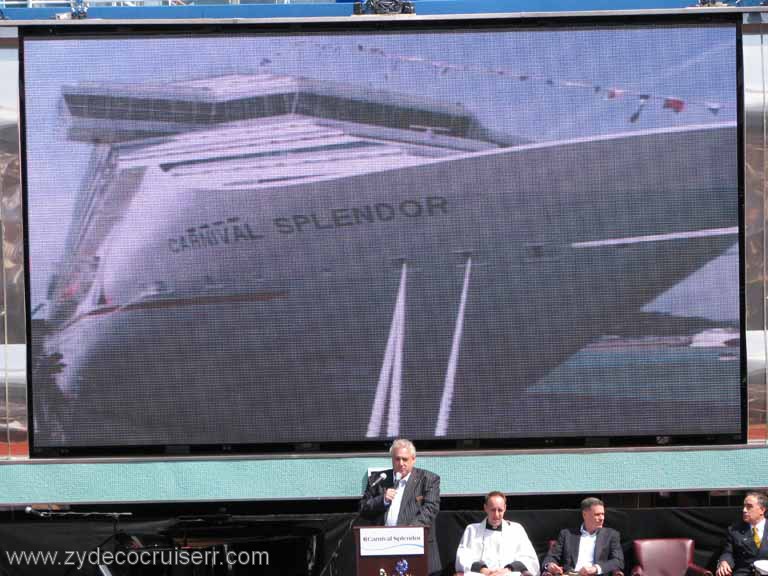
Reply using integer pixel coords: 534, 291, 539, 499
360, 438, 440, 574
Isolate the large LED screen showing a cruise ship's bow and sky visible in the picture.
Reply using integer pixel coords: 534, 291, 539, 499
23, 23, 742, 449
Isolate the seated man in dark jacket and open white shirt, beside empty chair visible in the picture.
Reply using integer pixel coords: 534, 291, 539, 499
543, 498, 624, 576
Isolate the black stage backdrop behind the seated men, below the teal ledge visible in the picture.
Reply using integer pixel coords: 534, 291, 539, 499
0, 506, 740, 576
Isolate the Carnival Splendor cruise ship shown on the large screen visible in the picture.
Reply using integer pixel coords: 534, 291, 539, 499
31, 74, 738, 446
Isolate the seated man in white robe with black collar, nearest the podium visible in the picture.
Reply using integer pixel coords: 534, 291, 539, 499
456, 492, 539, 576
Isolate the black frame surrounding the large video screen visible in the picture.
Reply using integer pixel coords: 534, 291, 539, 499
18, 12, 748, 458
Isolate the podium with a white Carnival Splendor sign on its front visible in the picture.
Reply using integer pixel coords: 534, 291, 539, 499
355, 526, 429, 576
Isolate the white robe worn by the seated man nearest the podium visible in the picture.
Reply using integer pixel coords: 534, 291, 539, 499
456, 520, 539, 576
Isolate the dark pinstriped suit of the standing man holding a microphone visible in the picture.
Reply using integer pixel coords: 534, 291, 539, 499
360, 468, 440, 573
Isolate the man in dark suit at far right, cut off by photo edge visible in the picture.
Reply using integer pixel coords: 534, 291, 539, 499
715, 492, 768, 576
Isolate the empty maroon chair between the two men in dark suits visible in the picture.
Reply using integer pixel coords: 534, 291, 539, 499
631, 538, 712, 576
